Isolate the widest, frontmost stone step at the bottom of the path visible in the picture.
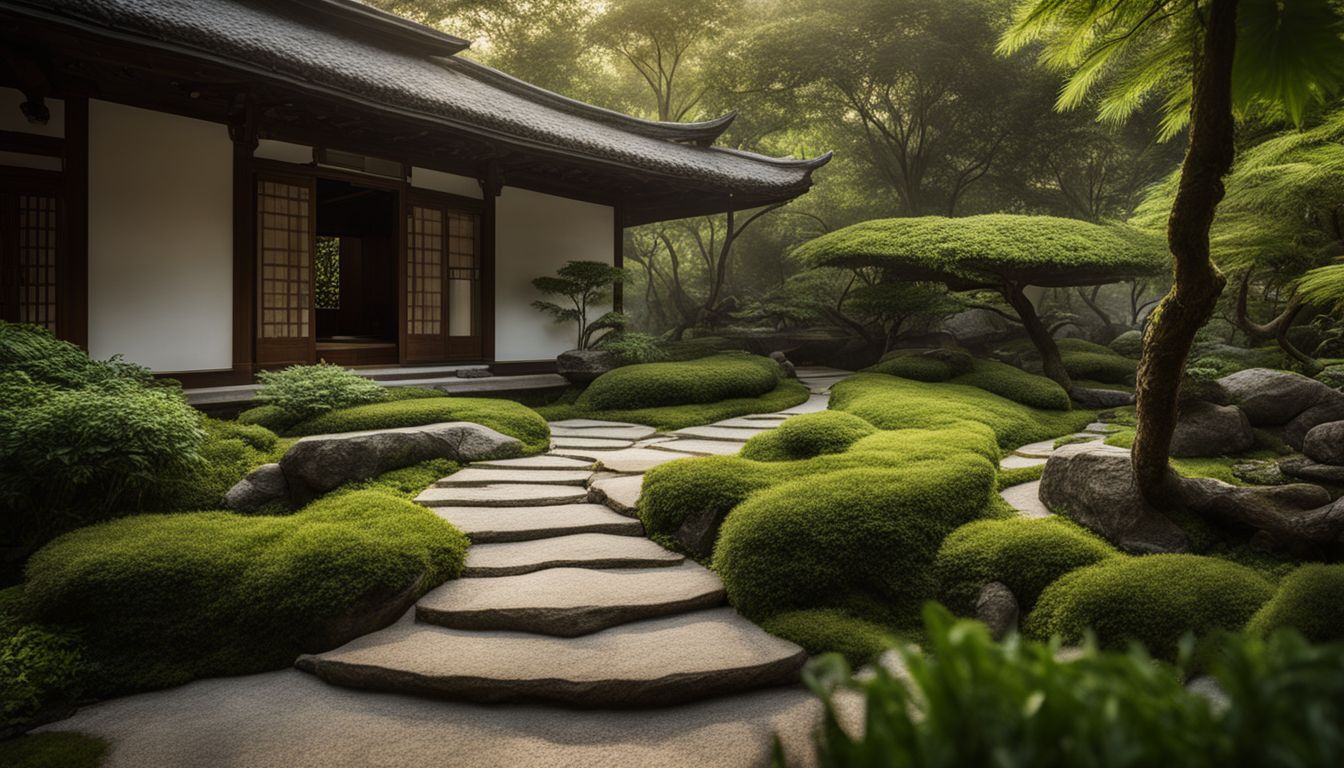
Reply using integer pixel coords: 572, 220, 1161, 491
296, 608, 808, 707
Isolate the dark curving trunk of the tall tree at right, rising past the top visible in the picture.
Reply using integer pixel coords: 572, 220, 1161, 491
1133, 0, 1236, 507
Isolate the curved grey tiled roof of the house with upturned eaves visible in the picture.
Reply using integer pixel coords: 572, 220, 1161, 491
13, 0, 829, 196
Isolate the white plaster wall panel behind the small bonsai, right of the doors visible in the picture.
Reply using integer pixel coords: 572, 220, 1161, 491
495, 187, 616, 360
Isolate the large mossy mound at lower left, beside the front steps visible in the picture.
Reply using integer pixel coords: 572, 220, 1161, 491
24, 491, 468, 694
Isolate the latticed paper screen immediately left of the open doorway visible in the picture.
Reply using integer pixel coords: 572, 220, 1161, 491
257, 182, 312, 339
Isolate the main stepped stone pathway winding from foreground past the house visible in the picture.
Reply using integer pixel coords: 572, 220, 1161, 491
296, 369, 848, 707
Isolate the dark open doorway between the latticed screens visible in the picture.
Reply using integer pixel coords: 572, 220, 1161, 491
313, 179, 398, 366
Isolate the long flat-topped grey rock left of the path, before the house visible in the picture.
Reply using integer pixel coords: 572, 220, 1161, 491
280, 421, 523, 506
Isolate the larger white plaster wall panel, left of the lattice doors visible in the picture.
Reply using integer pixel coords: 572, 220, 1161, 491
89, 101, 233, 371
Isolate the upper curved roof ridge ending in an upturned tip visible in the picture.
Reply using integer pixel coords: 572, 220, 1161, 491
437, 56, 738, 147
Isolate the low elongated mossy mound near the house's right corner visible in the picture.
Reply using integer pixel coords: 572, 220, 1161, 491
577, 354, 780, 410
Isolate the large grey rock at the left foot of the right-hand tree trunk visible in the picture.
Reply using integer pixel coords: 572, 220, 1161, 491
1040, 443, 1188, 554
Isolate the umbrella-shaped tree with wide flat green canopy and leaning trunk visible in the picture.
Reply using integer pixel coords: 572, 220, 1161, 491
794, 214, 1167, 390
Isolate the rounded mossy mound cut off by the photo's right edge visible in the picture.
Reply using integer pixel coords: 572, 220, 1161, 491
1246, 564, 1344, 642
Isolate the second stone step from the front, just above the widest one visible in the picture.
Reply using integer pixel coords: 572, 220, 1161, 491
415, 562, 727, 638
